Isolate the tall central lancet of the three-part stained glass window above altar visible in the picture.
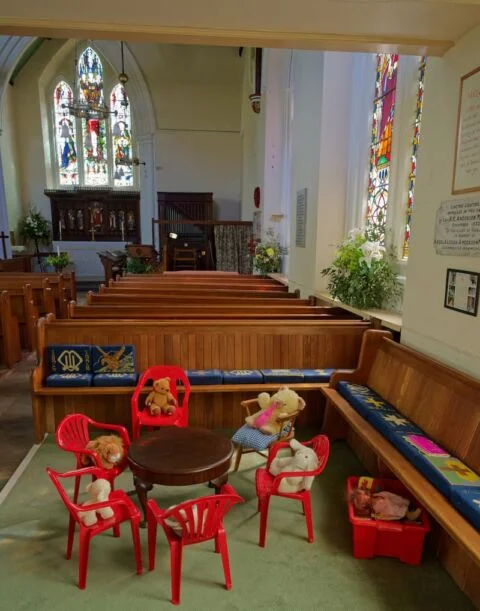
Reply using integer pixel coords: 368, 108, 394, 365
78, 47, 108, 186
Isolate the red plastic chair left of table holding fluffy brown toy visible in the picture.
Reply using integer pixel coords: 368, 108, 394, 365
55, 414, 130, 503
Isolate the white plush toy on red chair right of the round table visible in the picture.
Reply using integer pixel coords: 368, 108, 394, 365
270, 439, 318, 494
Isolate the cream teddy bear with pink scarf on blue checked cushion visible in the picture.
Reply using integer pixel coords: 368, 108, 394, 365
245, 386, 305, 435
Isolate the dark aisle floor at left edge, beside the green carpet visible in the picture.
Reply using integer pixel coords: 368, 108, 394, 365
0, 353, 36, 490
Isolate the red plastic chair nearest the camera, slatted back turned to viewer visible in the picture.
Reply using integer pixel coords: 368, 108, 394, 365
147, 484, 243, 605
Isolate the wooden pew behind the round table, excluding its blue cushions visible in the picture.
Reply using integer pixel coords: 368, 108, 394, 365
32, 315, 369, 441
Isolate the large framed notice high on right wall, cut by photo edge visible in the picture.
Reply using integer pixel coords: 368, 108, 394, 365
452, 66, 480, 194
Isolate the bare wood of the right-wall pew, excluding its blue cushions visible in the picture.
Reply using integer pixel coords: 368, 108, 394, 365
322, 330, 480, 603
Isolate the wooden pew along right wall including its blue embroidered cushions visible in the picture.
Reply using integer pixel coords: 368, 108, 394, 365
322, 330, 480, 604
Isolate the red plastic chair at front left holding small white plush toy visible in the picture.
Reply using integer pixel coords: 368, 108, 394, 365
47, 467, 143, 590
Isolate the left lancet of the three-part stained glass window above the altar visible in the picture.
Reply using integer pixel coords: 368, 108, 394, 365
54, 81, 78, 185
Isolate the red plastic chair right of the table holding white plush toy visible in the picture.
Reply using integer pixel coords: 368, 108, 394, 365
255, 435, 330, 547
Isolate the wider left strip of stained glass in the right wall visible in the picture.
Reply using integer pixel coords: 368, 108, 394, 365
366, 54, 398, 244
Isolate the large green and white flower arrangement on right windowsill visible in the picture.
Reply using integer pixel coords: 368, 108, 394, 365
322, 229, 401, 308
